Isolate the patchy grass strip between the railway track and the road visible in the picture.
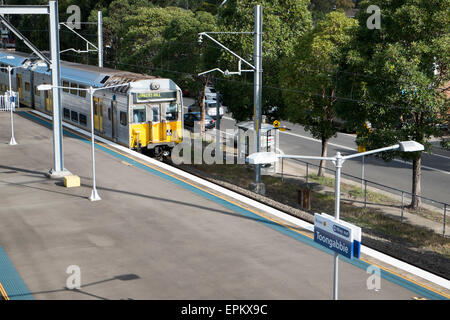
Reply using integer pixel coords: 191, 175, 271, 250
180, 164, 450, 258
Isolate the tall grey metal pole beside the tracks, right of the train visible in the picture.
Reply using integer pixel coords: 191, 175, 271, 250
254, 5, 262, 191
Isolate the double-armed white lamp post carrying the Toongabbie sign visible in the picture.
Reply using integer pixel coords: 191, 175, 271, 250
247, 141, 424, 300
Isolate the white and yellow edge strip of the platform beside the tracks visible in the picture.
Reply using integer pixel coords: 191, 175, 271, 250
23, 110, 450, 299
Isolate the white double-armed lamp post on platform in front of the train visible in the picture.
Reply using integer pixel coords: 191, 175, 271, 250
37, 82, 130, 201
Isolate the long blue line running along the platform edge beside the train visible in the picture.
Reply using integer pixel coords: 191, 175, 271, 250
16, 113, 449, 300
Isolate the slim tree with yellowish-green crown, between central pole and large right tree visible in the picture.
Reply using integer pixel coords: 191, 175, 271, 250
280, 11, 357, 176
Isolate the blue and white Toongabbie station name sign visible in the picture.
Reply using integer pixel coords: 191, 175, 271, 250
314, 213, 361, 259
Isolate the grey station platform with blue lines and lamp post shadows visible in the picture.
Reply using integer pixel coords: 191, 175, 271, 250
0, 110, 450, 300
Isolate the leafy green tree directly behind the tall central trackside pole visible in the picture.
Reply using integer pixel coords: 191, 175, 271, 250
211, 0, 312, 121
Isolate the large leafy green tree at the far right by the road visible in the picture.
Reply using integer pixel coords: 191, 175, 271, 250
341, 0, 450, 208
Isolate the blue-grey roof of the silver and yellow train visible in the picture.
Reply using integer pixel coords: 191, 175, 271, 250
0, 50, 157, 92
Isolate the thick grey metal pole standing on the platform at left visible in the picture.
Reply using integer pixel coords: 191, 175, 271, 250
49, 0, 64, 177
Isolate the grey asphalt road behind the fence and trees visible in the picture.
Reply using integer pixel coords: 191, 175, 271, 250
186, 99, 450, 203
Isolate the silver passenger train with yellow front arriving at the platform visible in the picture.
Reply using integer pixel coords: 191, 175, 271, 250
0, 50, 184, 158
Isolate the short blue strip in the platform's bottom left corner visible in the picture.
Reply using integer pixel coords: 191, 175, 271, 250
0, 246, 34, 300
